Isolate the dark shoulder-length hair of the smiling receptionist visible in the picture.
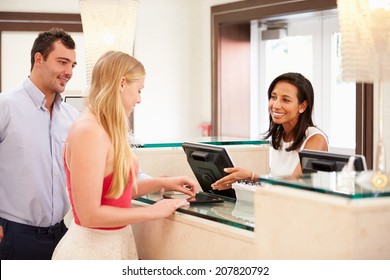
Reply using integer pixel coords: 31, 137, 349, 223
265, 72, 314, 151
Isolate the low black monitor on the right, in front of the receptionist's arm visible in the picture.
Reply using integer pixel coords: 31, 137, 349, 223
299, 150, 367, 173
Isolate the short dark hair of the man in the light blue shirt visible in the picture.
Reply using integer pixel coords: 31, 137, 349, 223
30, 28, 76, 71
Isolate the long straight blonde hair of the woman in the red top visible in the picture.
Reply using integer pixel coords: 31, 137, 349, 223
89, 51, 145, 198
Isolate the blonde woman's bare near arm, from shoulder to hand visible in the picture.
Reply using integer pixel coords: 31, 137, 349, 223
67, 121, 193, 228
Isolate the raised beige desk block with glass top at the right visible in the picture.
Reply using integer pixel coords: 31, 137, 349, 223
255, 172, 390, 259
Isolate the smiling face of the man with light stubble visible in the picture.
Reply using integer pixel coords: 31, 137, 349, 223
35, 41, 76, 94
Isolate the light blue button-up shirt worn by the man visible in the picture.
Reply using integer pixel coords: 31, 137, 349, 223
0, 78, 79, 227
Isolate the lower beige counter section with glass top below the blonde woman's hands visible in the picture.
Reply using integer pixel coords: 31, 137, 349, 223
133, 195, 255, 260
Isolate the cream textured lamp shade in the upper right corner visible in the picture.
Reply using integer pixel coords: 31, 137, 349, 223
337, 0, 390, 83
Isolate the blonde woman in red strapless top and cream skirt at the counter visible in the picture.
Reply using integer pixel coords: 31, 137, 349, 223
53, 51, 198, 259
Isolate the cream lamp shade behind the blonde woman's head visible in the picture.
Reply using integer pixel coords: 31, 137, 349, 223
79, 0, 139, 84
